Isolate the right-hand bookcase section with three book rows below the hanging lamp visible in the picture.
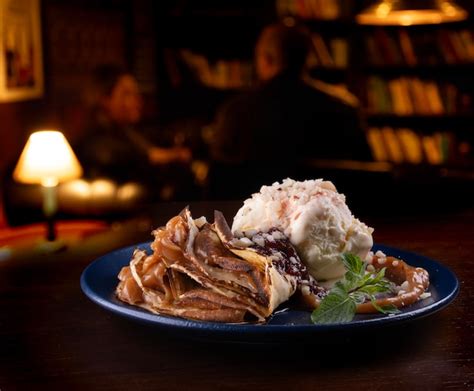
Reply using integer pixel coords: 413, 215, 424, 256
353, 19, 474, 173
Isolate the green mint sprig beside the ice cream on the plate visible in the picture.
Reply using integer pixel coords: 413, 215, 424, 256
311, 254, 399, 324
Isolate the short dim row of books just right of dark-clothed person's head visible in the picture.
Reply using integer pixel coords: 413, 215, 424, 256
308, 33, 349, 68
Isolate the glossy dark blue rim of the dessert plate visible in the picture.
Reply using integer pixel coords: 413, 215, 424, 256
80, 241, 460, 336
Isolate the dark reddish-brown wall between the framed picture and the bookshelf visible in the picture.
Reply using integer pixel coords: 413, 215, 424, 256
0, 0, 155, 175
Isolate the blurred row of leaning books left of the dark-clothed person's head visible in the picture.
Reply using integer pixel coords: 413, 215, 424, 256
179, 49, 254, 89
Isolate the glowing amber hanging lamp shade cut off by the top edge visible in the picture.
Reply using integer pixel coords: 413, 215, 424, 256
356, 0, 468, 26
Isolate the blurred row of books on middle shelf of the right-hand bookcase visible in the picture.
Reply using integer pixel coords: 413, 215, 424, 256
367, 76, 472, 115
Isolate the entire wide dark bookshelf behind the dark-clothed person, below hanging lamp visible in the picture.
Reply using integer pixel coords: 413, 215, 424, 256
157, 0, 474, 179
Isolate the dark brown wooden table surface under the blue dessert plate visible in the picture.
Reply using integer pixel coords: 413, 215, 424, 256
0, 202, 474, 391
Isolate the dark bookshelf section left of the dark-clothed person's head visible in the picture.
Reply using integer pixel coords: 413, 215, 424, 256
155, 0, 275, 124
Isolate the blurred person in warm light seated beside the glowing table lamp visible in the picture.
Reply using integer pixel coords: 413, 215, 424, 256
74, 65, 192, 202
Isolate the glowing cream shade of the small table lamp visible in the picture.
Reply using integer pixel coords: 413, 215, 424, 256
13, 130, 82, 186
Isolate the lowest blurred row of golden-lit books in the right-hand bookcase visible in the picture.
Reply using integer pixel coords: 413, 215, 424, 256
366, 126, 464, 164
